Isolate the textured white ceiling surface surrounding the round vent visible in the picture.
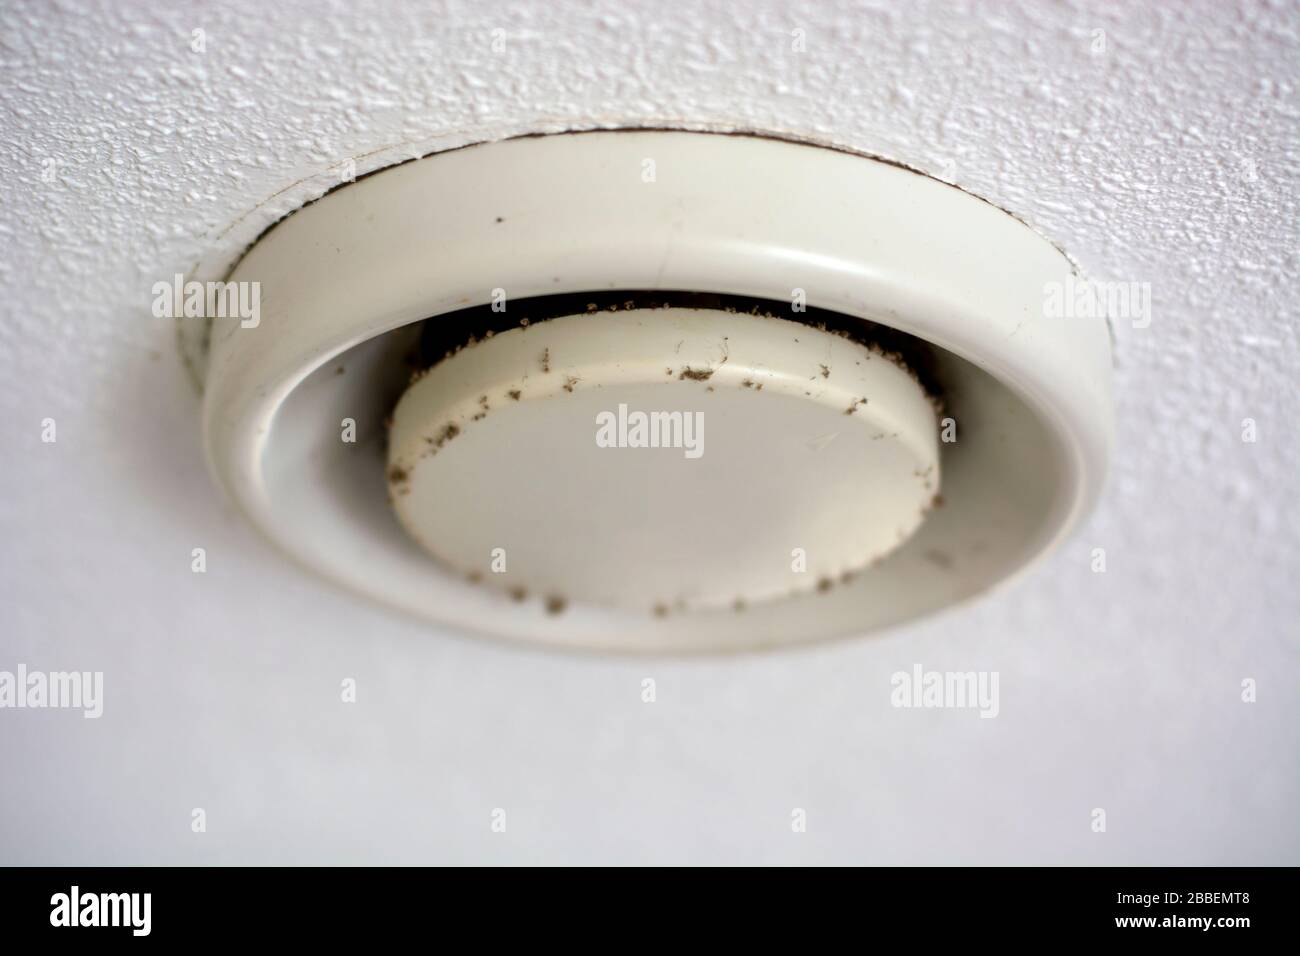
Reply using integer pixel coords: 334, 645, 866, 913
0, 0, 1300, 864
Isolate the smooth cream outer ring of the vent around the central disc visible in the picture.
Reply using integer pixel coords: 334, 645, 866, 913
203, 130, 1113, 652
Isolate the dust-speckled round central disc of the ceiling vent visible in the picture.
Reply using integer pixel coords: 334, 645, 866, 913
389, 308, 940, 615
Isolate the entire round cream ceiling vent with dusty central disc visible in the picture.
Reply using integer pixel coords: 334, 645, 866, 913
195, 130, 1112, 653
